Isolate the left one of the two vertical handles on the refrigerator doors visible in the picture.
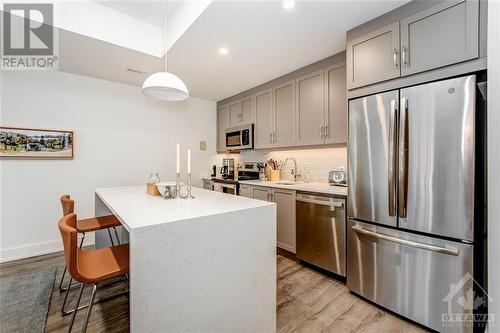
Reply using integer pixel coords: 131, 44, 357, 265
387, 99, 398, 216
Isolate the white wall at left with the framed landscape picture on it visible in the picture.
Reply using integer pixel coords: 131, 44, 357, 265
0, 71, 216, 261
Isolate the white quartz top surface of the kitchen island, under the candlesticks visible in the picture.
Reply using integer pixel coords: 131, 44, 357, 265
95, 185, 273, 231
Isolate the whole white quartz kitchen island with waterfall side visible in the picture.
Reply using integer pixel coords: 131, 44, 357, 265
95, 186, 276, 332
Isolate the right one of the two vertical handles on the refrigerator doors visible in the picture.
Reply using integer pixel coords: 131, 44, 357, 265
398, 97, 409, 218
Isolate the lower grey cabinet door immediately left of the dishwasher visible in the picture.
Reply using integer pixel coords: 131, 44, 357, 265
272, 189, 295, 253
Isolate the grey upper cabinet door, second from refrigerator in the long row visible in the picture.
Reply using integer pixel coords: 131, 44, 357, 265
296, 70, 325, 145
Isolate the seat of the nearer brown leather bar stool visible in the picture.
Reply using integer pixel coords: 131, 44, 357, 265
77, 244, 129, 284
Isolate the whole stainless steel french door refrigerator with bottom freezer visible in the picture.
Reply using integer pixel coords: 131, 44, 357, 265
347, 75, 476, 332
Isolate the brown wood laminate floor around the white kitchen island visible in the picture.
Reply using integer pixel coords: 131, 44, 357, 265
0, 253, 425, 333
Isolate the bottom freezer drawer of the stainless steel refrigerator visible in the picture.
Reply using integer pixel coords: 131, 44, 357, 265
347, 220, 473, 332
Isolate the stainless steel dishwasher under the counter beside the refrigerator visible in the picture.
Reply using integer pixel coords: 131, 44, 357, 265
296, 192, 346, 276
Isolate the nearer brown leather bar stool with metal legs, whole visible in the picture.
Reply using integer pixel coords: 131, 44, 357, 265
59, 213, 129, 333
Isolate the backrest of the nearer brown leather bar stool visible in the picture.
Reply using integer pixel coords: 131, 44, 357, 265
59, 213, 81, 281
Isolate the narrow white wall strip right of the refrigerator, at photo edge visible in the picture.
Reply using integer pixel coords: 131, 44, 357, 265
487, 1, 500, 333
